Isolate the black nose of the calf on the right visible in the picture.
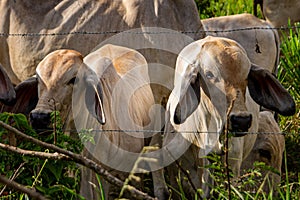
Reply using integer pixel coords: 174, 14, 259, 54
230, 115, 252, 136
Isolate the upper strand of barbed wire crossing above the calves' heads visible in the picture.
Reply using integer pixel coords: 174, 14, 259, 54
0, 26, 300, 37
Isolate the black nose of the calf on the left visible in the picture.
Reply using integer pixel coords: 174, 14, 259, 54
29, 111, 50, 130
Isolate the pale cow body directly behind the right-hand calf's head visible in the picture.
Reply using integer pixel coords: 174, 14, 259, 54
202, 13, 280, 73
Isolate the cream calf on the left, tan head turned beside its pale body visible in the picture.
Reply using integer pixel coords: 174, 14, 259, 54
30, 45, 158, 199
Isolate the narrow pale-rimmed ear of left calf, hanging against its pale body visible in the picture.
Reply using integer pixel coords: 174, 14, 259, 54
85, 70, 106, 125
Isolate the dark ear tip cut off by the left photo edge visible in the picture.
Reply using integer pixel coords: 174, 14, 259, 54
0, 64, 16, 105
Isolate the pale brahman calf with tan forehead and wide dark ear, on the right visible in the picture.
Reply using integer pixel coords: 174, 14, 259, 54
163, 36, 295, 199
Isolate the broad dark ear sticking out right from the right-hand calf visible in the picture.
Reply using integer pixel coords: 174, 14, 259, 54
248, 64, 296, 116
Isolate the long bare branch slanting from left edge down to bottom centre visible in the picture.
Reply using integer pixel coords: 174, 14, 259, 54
0, 121, 155, 200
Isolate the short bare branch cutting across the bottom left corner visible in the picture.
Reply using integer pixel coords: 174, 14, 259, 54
0, 176, 47, 200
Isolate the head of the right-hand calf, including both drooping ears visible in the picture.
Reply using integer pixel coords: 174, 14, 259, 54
171, 36, 295, 136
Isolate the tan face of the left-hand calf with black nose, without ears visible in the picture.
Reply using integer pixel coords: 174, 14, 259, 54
29, 50, 83, 129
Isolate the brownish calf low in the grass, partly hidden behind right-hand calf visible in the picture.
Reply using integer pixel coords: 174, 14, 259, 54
242, 111, 285, 193
